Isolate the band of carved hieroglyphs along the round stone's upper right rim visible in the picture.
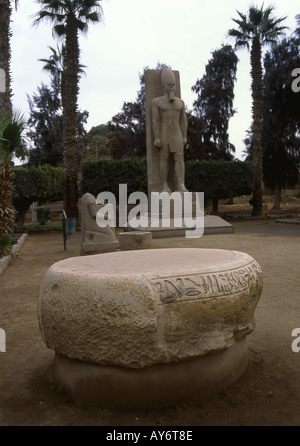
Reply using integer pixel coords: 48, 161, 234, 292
153, 262, 261, 303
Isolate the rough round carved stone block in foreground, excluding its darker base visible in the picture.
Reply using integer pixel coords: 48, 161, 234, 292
38, 248, 262, 368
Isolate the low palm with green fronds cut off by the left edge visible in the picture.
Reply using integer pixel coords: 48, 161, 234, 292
0, 111, 27, 237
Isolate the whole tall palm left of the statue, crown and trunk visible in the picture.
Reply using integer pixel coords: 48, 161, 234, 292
35, 0, 102, 218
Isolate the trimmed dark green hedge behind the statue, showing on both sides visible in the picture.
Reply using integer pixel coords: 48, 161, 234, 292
80, 158, 253, 211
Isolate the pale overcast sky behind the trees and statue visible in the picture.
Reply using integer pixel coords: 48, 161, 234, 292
12, 0, 300, 159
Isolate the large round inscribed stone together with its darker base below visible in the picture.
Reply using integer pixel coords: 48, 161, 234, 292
38, 248, 262, 408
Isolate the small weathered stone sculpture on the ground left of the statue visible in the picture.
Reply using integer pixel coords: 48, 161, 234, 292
80, 193, 119, 255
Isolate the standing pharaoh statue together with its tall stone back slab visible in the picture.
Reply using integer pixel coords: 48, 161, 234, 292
145, 66, 187, 196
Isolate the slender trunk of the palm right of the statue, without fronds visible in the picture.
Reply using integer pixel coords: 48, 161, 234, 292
251, 38, 263, 217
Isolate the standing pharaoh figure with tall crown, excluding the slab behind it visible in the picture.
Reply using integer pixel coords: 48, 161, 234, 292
152, 66, 187, 193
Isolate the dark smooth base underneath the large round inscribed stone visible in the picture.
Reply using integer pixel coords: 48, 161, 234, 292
55, 338, 248, 409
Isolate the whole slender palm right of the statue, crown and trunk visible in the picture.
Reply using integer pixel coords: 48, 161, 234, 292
228, 5, 286, 216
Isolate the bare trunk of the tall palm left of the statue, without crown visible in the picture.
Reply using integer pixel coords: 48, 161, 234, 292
62, 14, 79, 218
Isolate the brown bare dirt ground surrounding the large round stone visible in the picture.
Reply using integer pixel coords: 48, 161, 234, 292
0, 200, 300, 428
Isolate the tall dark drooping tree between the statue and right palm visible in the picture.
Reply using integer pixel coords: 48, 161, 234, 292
192, 45, 238, 160
